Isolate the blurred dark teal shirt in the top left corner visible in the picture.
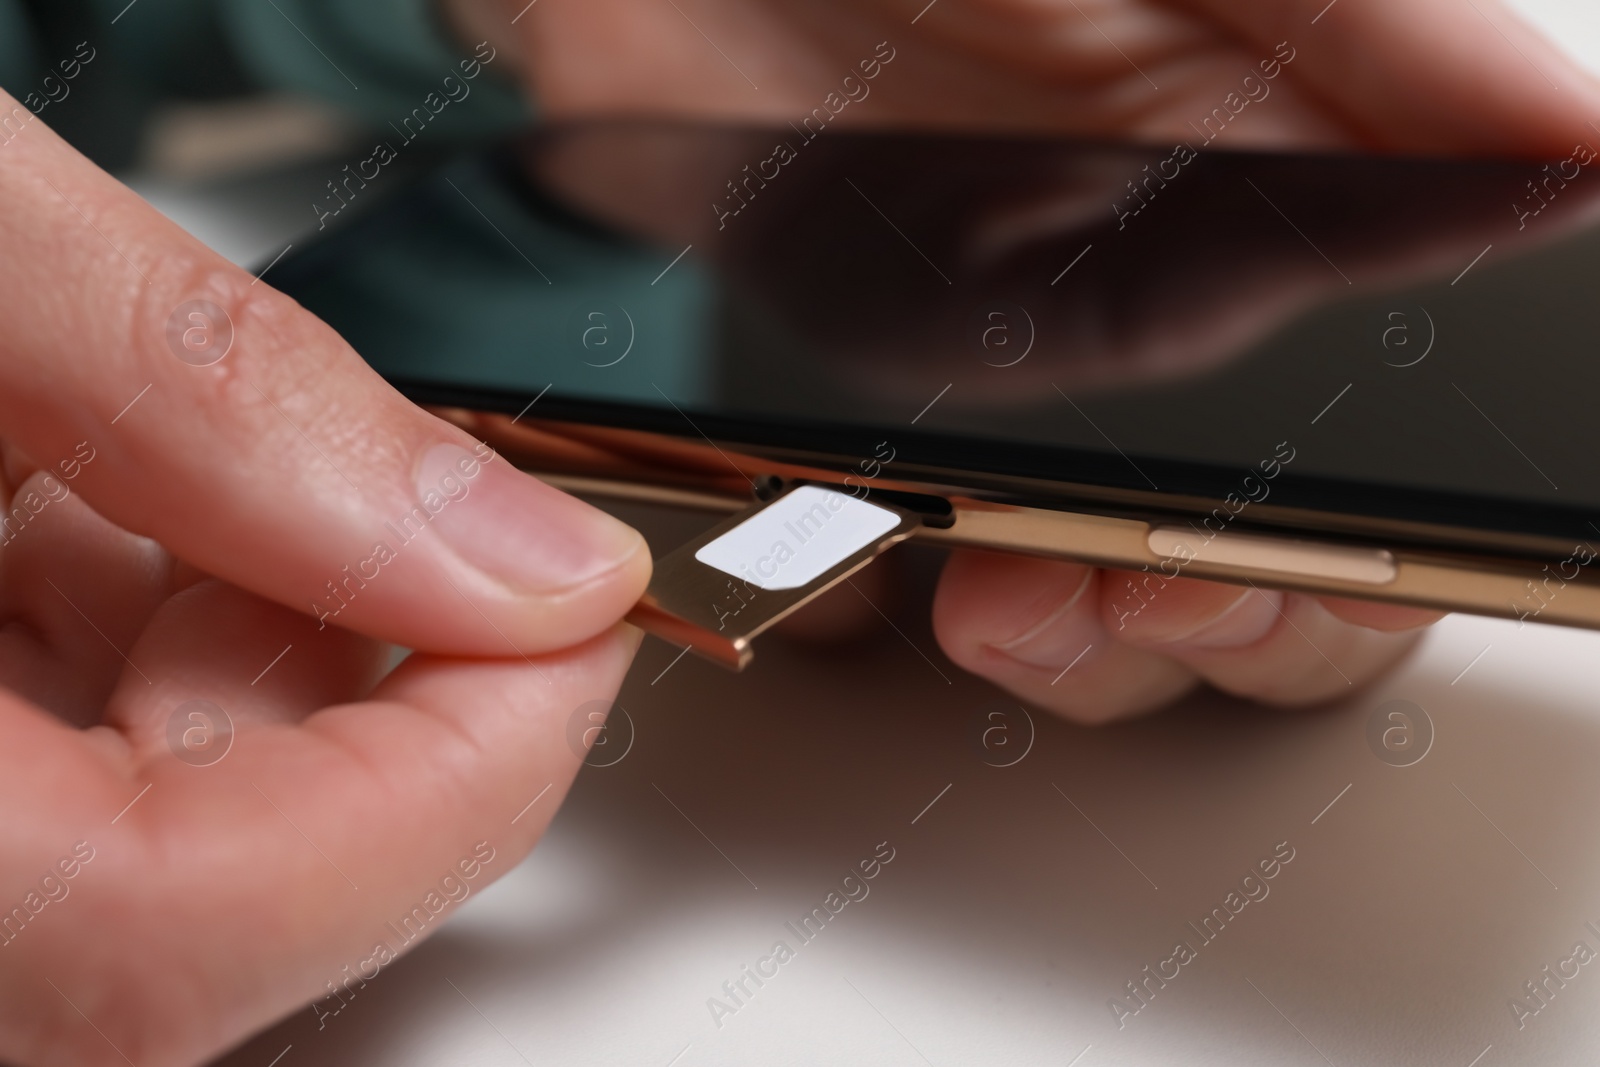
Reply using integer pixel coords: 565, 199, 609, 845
0, 0, 530, 170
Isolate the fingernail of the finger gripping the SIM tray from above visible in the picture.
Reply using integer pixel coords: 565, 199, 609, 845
416, 445, 645, 593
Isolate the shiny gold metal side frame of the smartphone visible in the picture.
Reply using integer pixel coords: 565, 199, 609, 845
430, 406, 1600, 646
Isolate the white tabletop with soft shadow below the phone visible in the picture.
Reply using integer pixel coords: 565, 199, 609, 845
226, 601, 1600, 1067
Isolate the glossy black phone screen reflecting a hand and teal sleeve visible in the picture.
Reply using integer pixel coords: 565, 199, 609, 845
268, 125, 1600, 543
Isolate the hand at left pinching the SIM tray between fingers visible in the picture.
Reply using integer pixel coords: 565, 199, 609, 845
0, 94, 650, 1067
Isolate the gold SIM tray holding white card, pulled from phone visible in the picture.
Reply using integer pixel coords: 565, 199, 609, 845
627, 485, 922, 670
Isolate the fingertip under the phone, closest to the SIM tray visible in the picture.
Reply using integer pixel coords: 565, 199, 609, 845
933, 552, 1198, 723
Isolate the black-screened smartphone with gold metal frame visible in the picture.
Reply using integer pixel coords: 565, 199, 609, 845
270, 120, 1600, 659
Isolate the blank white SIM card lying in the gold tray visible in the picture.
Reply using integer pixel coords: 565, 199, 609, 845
694, 485, 899, 589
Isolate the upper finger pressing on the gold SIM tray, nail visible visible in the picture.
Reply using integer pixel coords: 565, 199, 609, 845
0, 94, 650, 656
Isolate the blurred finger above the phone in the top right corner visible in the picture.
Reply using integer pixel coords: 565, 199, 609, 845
1196, 0, 1600, 155
